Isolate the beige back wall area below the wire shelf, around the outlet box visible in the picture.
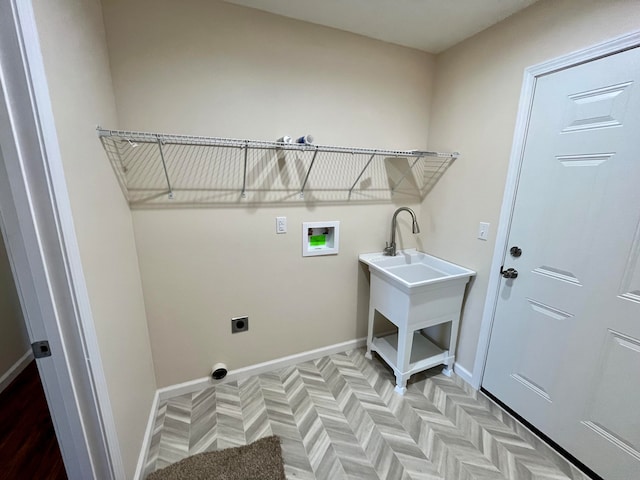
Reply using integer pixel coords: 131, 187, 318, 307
134, 205, 428, 385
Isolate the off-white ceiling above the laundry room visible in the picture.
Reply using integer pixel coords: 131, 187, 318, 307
225, 0, 536, 53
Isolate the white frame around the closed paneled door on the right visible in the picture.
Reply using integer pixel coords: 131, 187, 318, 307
471, 31, 640, 389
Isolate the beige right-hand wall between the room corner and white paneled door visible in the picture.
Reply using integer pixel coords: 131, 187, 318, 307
422, 0, 640, 371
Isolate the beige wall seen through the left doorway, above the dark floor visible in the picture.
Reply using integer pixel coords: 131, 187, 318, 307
0, 235, 30, 377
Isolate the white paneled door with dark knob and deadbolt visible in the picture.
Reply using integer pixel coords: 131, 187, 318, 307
482, 48, 640, 480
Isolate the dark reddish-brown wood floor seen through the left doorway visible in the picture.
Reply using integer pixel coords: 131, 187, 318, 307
0, 360, 67, 480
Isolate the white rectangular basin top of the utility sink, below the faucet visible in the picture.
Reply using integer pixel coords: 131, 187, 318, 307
359, 249, 476, 290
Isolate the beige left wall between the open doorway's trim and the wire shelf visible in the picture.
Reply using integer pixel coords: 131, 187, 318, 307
34, 0, 156, 478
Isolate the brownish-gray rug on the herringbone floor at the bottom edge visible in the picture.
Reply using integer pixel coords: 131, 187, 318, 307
147, 435, 286, 480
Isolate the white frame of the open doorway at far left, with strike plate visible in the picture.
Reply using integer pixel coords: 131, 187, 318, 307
0, 0, 125, 480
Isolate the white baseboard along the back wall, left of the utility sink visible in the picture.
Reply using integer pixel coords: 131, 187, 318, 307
158, 338, 366, 400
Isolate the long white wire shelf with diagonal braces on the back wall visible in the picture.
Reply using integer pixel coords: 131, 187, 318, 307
98, 128, 458, 207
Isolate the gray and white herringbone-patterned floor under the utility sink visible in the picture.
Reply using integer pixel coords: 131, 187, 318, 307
141, 349, 587, 480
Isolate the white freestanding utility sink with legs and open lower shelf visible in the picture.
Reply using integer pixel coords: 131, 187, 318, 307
359, 249, 475, 395
